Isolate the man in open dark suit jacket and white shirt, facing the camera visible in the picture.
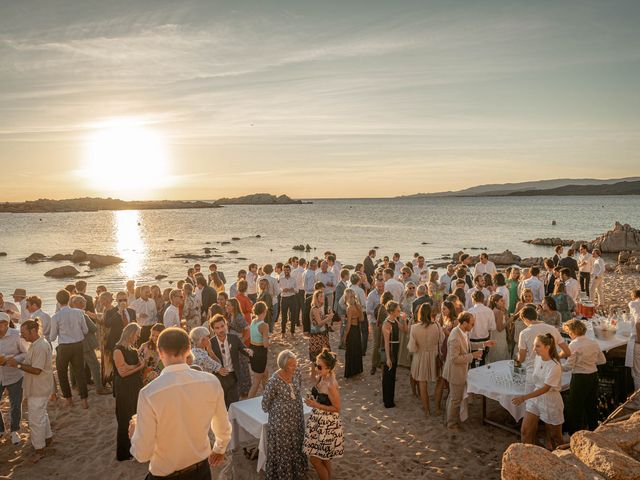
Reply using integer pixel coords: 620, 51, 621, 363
211, 315, 253, 410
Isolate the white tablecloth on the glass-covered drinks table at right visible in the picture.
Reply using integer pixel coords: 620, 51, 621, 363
467, 360, 571, 422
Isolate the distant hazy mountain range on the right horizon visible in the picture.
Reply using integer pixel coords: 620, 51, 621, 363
397, 177, 640, 198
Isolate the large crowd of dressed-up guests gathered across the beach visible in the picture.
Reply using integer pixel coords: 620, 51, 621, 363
0, 246, 640, 479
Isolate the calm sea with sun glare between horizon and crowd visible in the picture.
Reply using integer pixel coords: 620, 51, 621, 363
0, 196, 640, 310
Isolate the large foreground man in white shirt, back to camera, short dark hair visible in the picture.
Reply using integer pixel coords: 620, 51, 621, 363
129, 328, 231, 480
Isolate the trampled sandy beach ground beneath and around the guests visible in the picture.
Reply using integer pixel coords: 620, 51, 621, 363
0, 274, 640, 480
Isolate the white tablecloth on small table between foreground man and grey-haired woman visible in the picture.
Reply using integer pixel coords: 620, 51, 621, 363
229, 396, 311, 472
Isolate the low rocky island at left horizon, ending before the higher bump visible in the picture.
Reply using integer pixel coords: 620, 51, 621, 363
0, 197, 220, 213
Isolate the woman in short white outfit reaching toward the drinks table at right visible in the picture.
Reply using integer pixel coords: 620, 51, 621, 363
512, 333, 564, 450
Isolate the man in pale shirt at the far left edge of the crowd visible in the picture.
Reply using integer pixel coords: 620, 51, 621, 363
0, 312, 28, 445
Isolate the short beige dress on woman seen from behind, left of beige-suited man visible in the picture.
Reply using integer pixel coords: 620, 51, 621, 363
408, 323, 444, 382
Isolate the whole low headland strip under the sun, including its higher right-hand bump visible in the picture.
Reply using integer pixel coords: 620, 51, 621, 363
0, 193, 303, 213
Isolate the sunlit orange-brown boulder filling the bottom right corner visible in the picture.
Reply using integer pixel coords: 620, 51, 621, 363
571, 430, 640, 480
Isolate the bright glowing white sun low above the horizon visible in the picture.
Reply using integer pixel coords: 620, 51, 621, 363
80, 119, 171, 199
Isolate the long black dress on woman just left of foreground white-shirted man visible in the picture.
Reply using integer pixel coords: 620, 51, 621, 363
113, 345, 142, 461
